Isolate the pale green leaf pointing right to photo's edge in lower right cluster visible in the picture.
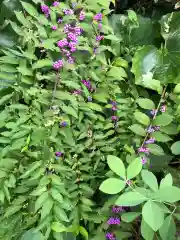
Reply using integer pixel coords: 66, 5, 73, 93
153, 186, 180, 203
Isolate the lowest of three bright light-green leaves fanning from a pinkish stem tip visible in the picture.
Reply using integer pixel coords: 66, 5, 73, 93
99, 178, 126, 194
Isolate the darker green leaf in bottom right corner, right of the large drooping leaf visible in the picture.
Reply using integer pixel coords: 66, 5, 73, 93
159, 215, 176, 240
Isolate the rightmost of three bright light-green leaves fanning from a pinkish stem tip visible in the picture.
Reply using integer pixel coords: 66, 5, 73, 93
127, 158, 142, 179
